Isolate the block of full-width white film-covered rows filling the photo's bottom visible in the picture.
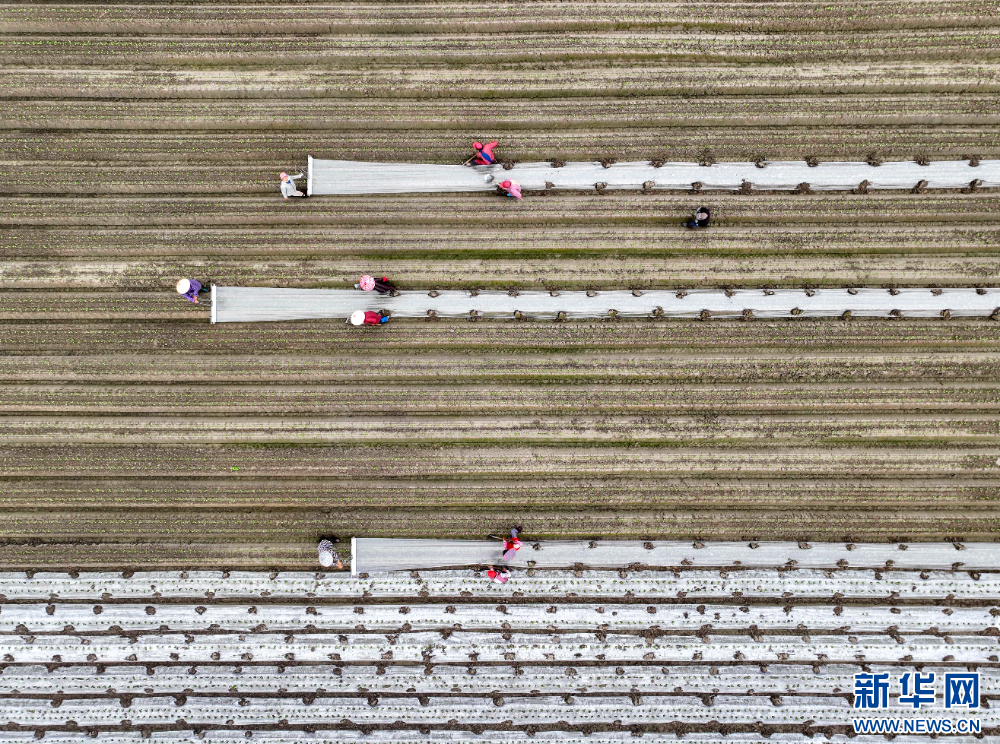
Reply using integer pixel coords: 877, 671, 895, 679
0, 560, 1000, 744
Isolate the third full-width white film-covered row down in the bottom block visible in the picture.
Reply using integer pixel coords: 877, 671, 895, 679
0, 628, 998, 670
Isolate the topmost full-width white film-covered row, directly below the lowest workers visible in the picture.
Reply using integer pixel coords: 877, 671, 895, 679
0, 568, 1000, 604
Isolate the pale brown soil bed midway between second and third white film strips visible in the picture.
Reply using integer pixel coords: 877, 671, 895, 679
4, 410, 1000, 444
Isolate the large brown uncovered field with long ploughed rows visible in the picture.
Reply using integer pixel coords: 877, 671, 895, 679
0, 0, 1000, 568
